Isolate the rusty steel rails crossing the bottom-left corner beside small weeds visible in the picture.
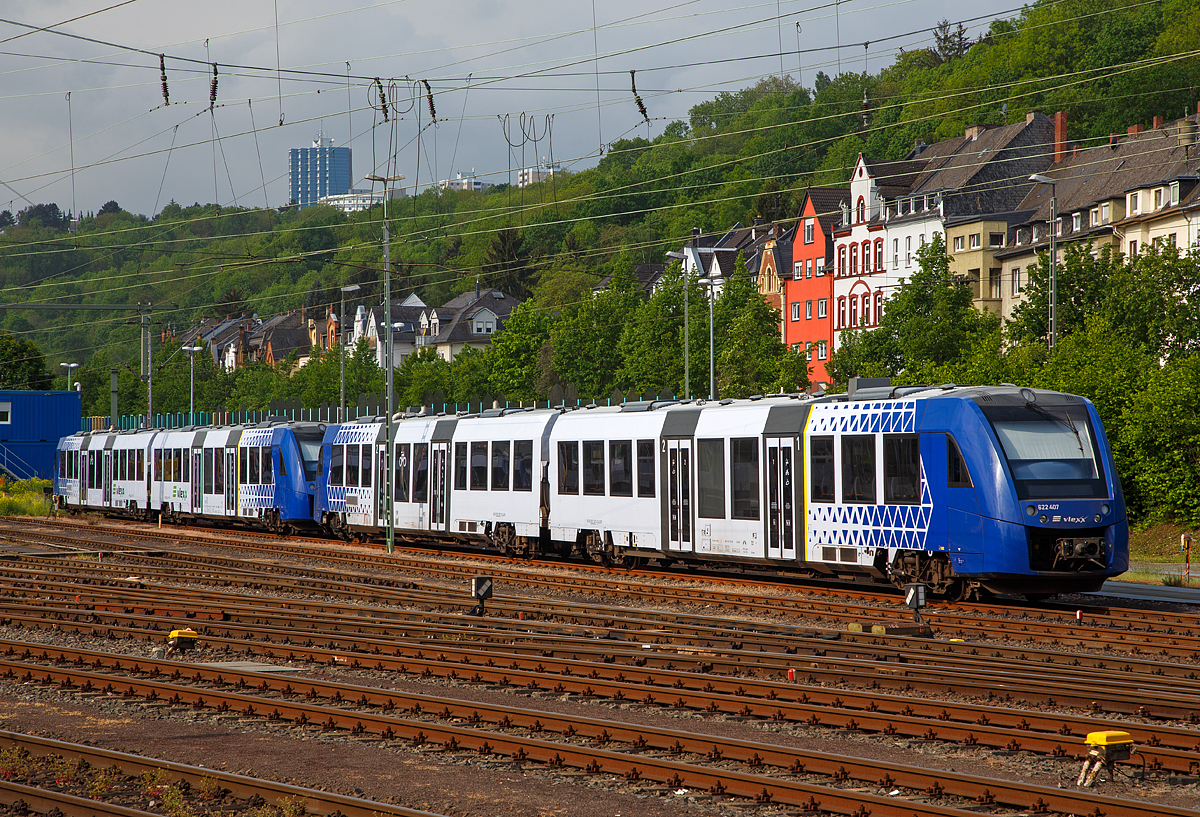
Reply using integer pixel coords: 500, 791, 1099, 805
0, 729, 439, 817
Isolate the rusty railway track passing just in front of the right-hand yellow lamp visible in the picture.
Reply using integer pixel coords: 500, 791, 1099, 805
0, 649, 1194, 817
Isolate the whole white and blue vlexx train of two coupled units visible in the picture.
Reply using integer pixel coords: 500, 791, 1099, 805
54, 385, 1129, 600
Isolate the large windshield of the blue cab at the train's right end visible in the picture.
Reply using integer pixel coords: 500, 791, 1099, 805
982, 403, 1109, 499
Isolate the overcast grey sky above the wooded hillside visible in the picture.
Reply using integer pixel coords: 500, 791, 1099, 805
0, 0, 1020, 215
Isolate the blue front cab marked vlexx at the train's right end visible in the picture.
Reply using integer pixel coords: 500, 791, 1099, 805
922, 388, 1129, 596
